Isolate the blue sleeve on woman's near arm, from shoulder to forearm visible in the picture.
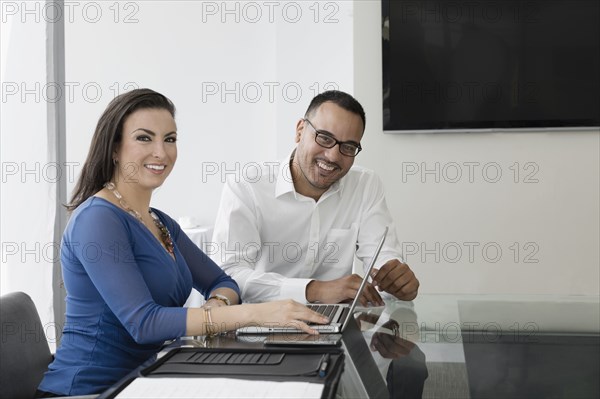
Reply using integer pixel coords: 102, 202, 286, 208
62, 206, 187, 344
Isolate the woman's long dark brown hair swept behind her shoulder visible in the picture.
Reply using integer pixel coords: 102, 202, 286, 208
66, 89, 175, 212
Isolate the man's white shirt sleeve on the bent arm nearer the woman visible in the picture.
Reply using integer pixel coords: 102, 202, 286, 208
210, 179, 311, 302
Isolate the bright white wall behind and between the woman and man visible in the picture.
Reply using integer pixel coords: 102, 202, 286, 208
66, 1, 353, 224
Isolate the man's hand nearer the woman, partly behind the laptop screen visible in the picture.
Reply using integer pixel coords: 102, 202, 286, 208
306, 274, 385, 306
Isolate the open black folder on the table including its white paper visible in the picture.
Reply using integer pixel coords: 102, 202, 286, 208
98, 346, 345, 399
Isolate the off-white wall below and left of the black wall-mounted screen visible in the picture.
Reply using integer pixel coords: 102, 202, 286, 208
354, 1, 600, 295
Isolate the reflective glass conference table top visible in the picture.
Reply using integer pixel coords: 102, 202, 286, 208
101, 294, 600, 399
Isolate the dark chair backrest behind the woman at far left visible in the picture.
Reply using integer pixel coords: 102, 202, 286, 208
0, 292, 52, 399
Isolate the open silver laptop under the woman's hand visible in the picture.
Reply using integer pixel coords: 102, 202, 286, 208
237, 227, 388, 334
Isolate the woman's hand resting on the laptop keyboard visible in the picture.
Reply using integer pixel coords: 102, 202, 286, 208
250, 299, 329, 334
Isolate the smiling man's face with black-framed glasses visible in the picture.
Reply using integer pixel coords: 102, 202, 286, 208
291, 102, 364, 201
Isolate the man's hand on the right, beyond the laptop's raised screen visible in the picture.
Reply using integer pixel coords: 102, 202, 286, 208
371, 259, 419, 301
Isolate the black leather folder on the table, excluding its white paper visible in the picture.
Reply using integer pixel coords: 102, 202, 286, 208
107, 347, 344, 399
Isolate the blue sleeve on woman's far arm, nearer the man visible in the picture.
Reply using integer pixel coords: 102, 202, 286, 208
159, 211, 241, 299
